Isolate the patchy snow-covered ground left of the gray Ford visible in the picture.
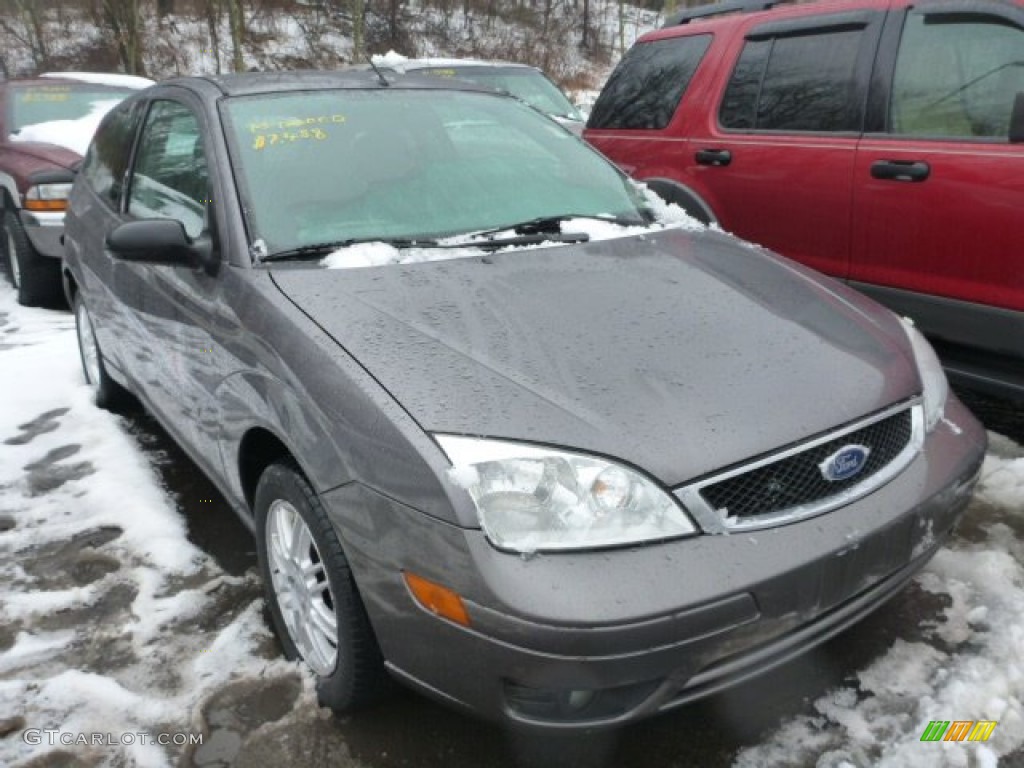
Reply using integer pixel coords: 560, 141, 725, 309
0, 285, 301, 766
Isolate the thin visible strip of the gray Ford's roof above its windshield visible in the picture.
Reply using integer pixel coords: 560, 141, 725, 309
172, 70, 494, 96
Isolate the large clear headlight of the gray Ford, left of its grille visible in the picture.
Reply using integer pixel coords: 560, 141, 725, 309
436, 435, 696, 552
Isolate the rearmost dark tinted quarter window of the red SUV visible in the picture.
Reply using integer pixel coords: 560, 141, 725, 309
587, 35, 712, 129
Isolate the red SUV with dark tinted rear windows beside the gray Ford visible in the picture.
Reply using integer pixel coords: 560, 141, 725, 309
584, 0, 1024, 398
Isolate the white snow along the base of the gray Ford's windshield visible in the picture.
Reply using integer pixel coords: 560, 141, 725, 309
321, 184, 705, 269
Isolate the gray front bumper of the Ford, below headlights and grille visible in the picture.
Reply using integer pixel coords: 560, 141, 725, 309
325, 397, 985, 728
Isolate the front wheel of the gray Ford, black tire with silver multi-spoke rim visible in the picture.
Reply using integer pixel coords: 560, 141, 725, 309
255, 462, 388, 713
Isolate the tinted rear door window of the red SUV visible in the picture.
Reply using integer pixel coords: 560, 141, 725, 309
719, 28, 866, 132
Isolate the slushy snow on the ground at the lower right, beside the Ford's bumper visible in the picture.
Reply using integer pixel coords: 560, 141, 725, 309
735, 435, 1024, 768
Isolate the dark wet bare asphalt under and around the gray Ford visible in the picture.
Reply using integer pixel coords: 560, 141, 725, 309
110, 392, 1024, 768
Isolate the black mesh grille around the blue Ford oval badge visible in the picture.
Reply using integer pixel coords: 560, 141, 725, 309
700, 408, 913, 519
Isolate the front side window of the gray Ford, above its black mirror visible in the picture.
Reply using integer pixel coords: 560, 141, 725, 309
128, 101, 210, 238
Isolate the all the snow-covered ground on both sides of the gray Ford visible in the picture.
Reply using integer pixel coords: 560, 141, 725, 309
0, 284, 1024, 768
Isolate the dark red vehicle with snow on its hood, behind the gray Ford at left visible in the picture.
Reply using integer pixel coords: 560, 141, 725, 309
0, 73, 142, 305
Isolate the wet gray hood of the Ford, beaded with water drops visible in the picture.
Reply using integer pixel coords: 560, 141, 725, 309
272, 230, 920, 485
